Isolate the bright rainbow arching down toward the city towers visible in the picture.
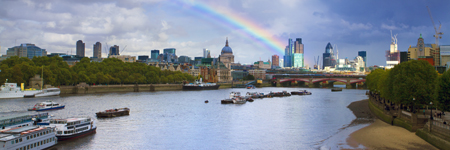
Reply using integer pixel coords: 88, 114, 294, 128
172, 0, 287, 56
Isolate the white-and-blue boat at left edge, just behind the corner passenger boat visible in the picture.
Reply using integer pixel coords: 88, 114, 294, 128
0, 113, 50, 130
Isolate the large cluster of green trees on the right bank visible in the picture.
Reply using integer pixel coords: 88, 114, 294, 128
366, 60, 450, 111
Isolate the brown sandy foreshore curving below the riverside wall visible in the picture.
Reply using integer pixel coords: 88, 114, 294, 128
347, 100, 437, 150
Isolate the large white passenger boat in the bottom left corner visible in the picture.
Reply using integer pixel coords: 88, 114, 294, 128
0, 126, 58, 150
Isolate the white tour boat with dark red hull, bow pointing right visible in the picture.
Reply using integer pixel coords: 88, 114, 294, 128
48, 117, 97, 141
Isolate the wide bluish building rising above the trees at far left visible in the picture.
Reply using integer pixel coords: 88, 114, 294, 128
6, 43, 47, 59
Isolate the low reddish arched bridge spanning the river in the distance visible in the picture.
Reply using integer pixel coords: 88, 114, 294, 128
272, 74, 366, 88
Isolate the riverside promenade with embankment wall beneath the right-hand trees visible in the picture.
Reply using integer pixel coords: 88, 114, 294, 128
367, 92, 450, 150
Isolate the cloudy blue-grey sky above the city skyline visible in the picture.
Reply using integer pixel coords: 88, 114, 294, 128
0, 0, 450, 66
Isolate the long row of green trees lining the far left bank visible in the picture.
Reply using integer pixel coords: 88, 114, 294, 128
0, 56, 195, 86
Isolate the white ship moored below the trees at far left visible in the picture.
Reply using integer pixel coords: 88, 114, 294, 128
0, 80, 61, 99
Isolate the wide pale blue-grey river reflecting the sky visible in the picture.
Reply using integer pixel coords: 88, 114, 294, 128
0, 88, 367, 150
